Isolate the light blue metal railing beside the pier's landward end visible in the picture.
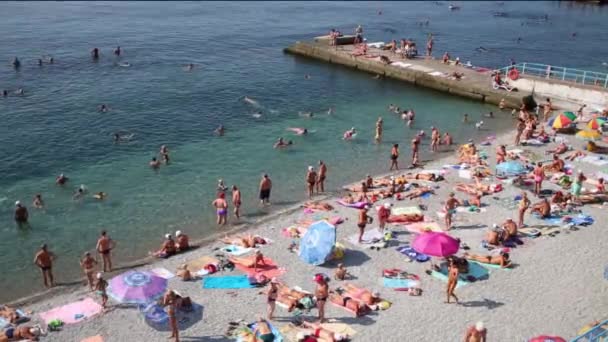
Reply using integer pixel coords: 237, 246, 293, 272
500, 63, 608, 88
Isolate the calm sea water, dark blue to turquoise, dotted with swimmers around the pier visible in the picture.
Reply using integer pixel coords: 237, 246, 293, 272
0, 2, 608, 300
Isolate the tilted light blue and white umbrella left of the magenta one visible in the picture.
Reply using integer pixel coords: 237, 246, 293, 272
298, 221, 336, 266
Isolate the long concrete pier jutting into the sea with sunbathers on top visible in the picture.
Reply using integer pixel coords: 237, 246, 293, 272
284, 42, 608, 108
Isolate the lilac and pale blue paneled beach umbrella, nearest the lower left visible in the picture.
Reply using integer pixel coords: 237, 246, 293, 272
108, 271, 167, 304
